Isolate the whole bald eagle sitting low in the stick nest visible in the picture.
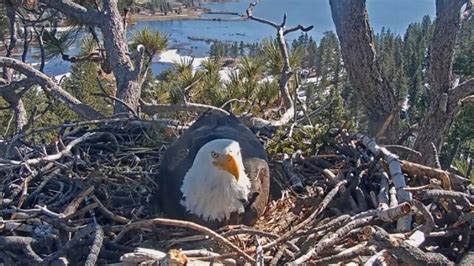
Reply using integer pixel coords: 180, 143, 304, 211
157, 112, 270, 228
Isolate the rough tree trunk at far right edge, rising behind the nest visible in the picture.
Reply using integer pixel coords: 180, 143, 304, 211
410, 0, 473, 165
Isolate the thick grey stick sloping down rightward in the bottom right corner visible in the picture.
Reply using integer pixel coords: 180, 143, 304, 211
364, 226, 454, 265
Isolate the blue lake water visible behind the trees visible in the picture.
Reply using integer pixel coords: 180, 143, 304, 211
33, 0, 435, 75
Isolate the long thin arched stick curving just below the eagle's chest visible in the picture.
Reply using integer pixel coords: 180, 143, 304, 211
114, 218, 255, 263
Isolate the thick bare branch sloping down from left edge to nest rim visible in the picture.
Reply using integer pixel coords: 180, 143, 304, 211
0, 57, 104, 119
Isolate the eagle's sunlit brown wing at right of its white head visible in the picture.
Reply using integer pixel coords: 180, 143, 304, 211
242, 158, 270, 226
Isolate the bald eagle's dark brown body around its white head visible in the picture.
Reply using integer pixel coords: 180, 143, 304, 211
158, 112, 270, 228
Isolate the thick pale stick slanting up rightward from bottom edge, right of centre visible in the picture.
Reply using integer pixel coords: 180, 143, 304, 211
290, 216, 375, 265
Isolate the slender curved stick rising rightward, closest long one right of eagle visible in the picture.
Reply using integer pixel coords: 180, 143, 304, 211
263, 180, 347, 250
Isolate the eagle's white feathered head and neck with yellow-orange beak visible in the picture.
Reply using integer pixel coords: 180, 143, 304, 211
181, 139, 250, 221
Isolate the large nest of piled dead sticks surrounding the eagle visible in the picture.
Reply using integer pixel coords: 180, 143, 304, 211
0, 120, 474, 265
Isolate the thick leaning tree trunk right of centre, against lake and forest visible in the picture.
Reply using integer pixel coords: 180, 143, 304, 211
330, 0, 399, 143
